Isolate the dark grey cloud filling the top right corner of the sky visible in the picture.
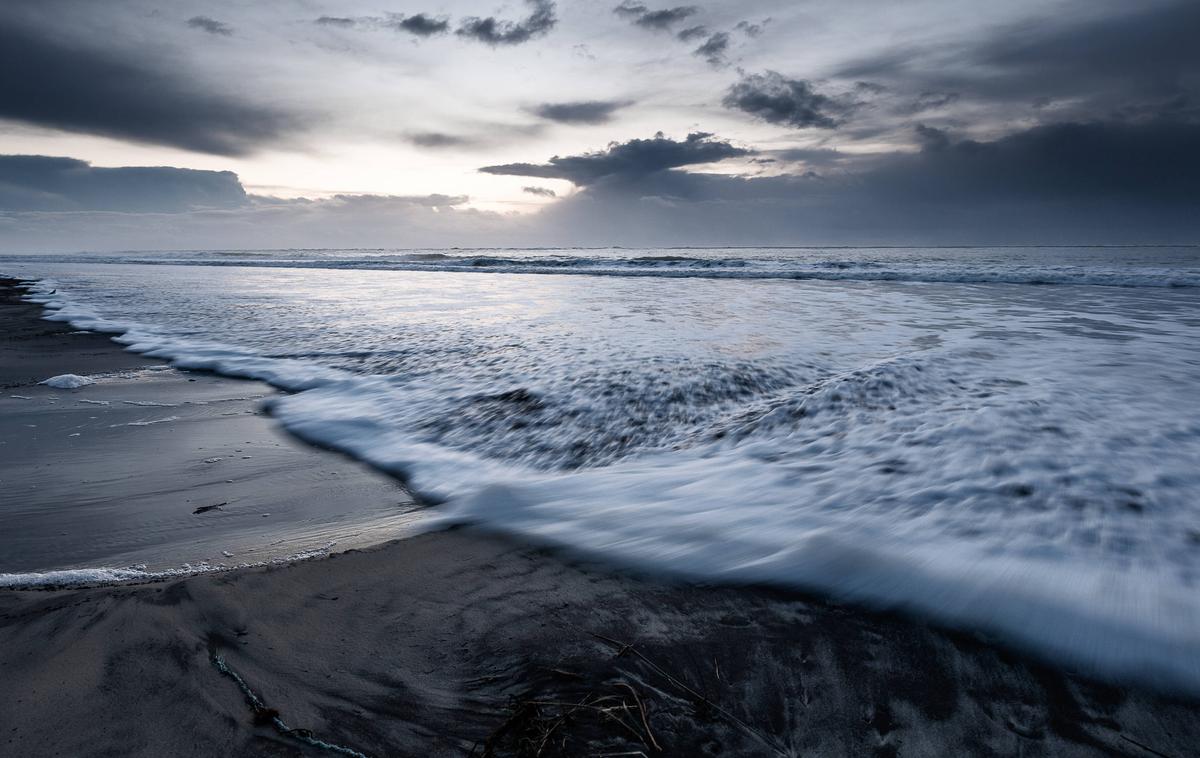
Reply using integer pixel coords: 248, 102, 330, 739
838, 0, 1200, 119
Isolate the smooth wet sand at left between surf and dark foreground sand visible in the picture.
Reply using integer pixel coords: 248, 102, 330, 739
0, 278, 420, 584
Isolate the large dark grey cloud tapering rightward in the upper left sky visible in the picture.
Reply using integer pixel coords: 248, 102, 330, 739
0, 23, 302, 156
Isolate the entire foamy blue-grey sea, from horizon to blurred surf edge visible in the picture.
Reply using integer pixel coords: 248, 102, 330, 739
0, 248, 1200, 688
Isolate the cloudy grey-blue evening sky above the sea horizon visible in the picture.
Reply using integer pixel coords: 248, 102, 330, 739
0, 0, 1200, 252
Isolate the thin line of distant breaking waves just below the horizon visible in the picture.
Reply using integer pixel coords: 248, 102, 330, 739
6, 251, 1200, 288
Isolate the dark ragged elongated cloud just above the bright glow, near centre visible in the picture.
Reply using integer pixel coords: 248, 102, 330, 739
479, 132, 751, 186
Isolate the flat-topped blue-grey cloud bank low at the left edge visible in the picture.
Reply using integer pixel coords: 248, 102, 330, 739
0, 155, 247, 213
